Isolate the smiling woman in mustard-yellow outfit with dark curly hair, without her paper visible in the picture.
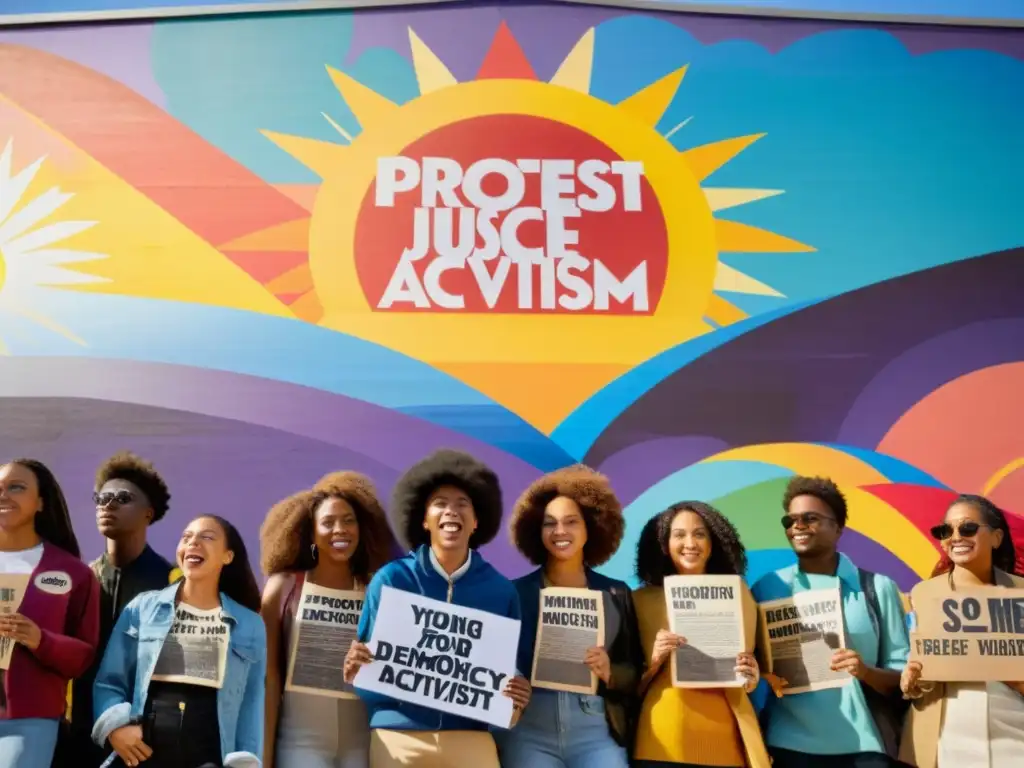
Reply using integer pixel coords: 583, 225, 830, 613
633, 502, 769, 768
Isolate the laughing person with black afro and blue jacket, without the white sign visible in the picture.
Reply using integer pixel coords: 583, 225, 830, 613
345, 450, 530, 768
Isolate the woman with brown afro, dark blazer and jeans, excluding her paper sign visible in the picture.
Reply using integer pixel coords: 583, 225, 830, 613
498, 466, 642, 768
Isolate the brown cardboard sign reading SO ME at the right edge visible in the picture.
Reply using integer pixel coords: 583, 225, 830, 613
910, 587, 1024, 683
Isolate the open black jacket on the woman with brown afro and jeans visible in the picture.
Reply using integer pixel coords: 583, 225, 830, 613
513, 568, 643, 749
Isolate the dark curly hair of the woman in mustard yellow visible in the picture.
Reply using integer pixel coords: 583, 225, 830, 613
636, 502, 746, 587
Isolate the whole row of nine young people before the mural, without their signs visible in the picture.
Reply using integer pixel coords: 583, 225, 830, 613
0, 451, 1024, 768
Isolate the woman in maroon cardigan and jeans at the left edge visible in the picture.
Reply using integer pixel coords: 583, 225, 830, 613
0, 459, 99, 768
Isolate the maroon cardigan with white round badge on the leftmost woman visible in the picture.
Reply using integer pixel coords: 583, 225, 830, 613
0, 542, 99, 720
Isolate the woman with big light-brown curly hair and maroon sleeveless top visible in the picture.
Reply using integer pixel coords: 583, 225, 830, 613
260, 472, 393, 768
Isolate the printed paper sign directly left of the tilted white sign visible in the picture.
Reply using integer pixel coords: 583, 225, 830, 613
285, 579, 362, 698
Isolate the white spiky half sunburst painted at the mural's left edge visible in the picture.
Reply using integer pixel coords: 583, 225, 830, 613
0, 139, 104, 354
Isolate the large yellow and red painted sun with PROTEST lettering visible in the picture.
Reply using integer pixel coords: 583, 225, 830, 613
264, 25, 814, 431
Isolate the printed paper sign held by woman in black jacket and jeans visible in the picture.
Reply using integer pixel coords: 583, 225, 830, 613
530, 587, 604, 694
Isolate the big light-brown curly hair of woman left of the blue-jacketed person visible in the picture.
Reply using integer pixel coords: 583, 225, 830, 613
259, 472, 393, 585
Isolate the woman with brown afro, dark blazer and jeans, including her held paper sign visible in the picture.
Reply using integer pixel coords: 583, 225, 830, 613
498, 466, 642, 768
